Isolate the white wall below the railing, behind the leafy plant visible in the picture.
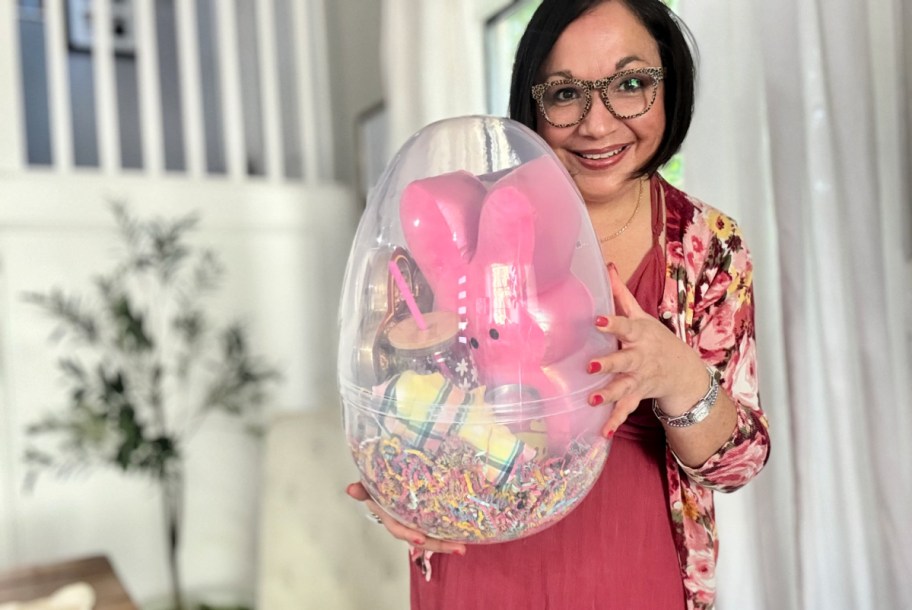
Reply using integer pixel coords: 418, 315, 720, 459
0, 172, 357, 600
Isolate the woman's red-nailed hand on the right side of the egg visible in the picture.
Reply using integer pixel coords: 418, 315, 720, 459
588, 263, 709, 438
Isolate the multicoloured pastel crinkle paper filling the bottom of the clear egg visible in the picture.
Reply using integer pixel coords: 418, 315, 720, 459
352, 436, 609, 543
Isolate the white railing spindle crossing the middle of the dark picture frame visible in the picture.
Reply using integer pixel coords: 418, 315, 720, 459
92, 0, 121, 173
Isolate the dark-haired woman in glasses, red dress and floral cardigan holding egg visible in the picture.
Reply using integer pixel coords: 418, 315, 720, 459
348, 0, 769, 610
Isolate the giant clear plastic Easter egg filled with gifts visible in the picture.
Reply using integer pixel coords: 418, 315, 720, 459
338, 116, 617, 543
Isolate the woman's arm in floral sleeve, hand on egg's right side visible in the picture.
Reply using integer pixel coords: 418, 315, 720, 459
593, 249, 769, 491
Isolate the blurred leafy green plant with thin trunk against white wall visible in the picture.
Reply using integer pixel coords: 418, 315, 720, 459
25, 204, 278, 610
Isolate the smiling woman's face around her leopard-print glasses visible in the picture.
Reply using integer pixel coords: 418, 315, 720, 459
537, 0, 665, 204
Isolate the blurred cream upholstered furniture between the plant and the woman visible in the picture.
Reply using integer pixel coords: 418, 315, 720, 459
257, 409, 408, 610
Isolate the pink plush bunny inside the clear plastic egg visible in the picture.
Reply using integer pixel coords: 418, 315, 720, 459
399, 156, 595, 446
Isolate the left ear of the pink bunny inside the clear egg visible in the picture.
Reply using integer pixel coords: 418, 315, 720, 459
399, 171, 486, 299
